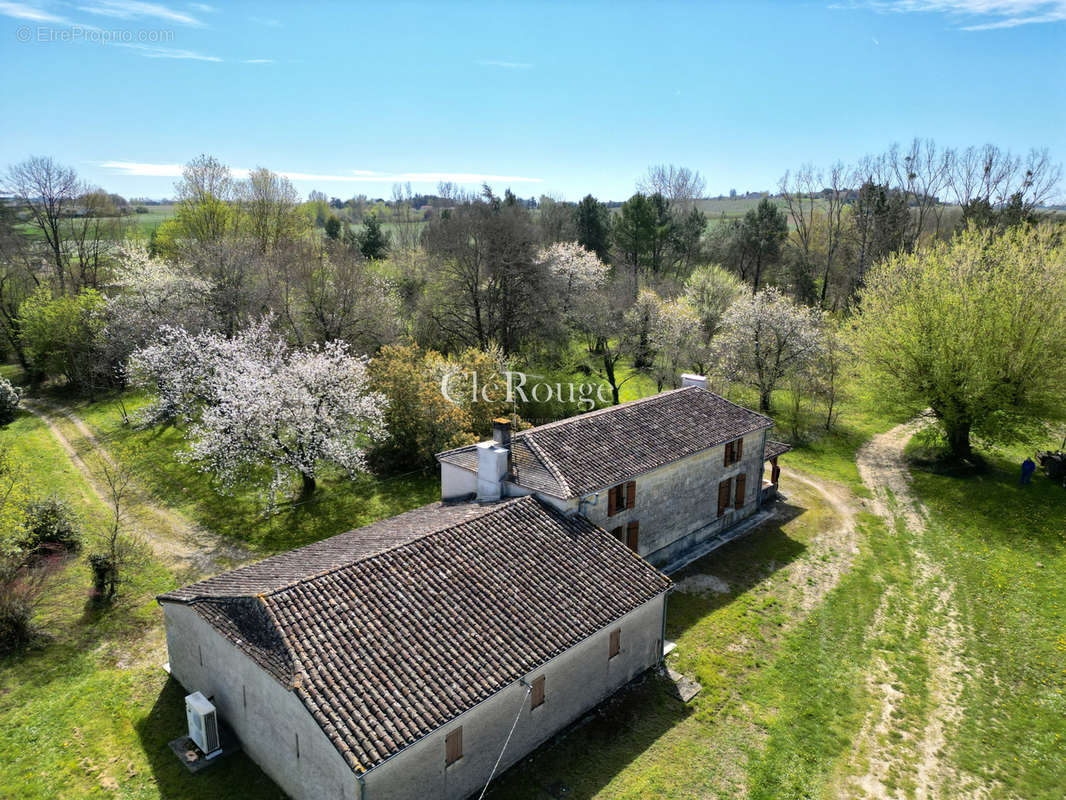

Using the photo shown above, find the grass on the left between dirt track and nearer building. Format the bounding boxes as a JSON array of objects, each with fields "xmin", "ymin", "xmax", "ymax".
[{"xmin": 0, "ymin": 412, "xmax": 279, "ymax": 800}]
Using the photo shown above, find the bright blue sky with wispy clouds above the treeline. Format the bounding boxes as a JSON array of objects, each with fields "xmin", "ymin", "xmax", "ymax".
[{"xmin": 0, "ymin": 0, "xmax": 1066, "ymax": 199}]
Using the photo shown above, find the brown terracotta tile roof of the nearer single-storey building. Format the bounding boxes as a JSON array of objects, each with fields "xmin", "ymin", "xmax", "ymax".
[{"xmin": 160, "ymin": 497, "xmax": 671, "ymax": 771}]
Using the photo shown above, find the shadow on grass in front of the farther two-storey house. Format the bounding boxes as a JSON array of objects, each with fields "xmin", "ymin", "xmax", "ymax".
[{"xmin": 666, "ymin": 500, "xmax": 807, "ymax": 639}]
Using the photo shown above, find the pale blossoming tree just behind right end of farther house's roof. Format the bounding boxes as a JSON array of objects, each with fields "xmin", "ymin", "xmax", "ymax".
[{"xmin": 714, "ymin": 288, "xmax": 821, "ymax": 412}]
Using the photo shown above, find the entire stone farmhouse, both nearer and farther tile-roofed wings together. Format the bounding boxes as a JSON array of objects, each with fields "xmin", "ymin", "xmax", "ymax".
[{"xmin": 159, "ymin": 385, "xmax": 788, "ymax": 800}]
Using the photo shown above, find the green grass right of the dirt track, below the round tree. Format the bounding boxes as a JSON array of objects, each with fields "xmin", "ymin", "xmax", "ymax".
[{"xmin": 911, "ymin": 443, "xmax": 1066, "ymax": 799}]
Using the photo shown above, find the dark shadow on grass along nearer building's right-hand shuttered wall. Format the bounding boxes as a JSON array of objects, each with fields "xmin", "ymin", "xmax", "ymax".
[{"xmin": 486, "ymin": 671, "xmax": 692, "ymax": 800}]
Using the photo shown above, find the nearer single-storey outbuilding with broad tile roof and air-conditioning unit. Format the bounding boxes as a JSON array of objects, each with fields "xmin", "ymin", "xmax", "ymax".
[{"xmin": 159, "ymin": 496, "xmax": 671, "ymax": 800}]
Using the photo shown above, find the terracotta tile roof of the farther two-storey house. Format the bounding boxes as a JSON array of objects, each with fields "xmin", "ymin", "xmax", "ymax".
[{"xmin": 437, "ymin": 386, "xmax": 773, "ymax": 498}]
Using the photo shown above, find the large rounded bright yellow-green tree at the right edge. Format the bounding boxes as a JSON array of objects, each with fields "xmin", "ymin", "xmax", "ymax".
[{"xmin": 857, "ymin": 227, "xmax": 1066, "ymax": 460}]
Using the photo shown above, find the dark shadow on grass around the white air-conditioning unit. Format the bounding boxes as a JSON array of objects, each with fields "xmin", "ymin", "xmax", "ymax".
[{"xmin": 134, "ymin": 677, "xmax": 286, "ymax": 800}]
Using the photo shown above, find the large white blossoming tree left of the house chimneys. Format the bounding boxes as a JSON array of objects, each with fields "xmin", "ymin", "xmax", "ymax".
[{"xmin": 132, "ymin": 322, "xmax": 386, "ymax": 498}]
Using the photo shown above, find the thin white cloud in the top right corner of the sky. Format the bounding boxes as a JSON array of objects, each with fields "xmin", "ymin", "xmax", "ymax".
[{"xmin": 848, "ymin": 0, "xmax": 1066, "ymax": 31}]
